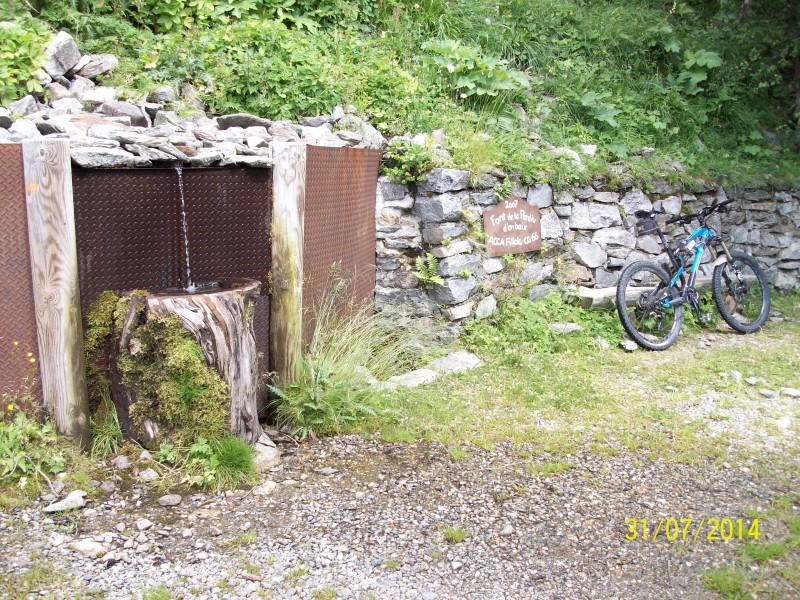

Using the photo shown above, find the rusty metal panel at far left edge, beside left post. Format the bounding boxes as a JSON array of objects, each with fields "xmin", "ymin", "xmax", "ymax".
[{"xmin": 0, "ymin": 144, "xmax": 42, "ymax": 415}]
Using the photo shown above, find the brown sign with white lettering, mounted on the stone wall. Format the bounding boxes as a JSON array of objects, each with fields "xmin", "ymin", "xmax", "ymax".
[{"xmin": 483, "ymin": 197, "xmax": 542, "ymax": 256}]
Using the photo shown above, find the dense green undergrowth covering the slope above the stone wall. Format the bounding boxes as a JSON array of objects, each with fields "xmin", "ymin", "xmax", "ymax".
[{"xmin": 6, "ymin": 0, "xmax": 800, "ymax": 186}]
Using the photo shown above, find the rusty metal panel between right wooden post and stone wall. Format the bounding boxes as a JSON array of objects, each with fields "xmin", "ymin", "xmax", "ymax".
[{"xmin": 303, "ymin": 146, "xmax": 381, "ymax": 314}]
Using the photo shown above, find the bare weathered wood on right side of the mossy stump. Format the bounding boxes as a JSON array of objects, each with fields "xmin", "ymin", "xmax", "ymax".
[{"xmin": 146, "ymin": 279, "xmax": 261, "ymax": 444}]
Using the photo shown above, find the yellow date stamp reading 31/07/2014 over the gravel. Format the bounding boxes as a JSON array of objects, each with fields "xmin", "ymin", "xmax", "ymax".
[{"xmin": 625, "ymin": 517, "xmax": 759, "ymax": 542}]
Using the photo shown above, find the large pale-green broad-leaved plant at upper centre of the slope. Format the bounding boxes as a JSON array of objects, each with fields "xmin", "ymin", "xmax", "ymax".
[{"xmin": 422, "ymin": 40, "xmax": 530, "ymax": 100}]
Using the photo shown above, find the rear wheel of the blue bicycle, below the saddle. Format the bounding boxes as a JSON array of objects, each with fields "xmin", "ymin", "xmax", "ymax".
[{"xmin": 617, "ymin": 261, "xmax": 683, "ymax": 350}]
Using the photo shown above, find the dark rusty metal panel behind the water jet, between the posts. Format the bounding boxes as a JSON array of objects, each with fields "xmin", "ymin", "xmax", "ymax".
[{"xmin": 73, "ymin": 168, "xmax": 272, "ymax": 406}]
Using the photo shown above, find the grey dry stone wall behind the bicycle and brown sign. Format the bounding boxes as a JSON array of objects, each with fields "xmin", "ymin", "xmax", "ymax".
[{"xmin": 375, "ymin": 169, "xmax": 800, "ymax": 321}]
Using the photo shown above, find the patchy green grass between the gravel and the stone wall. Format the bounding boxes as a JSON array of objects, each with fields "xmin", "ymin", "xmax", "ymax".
[{"xmin": 351, "ymin": 295, "xmax": 800, "ymax": 471}]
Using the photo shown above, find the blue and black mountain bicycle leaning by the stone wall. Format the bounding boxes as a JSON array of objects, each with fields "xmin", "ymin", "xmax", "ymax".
[{"xmin": 616, "ymin": 200, "xmax": 770, "ymax": 350}]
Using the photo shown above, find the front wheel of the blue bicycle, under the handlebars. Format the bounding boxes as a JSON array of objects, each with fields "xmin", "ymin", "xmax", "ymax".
[{"xmin": 711, "ymin": 251, "xmax": 769, "ymax": 333}]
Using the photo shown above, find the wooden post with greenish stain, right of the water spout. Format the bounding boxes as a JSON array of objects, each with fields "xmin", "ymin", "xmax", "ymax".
[{"xmin": 269, "ymin": 143, "xmax": 306, "ymax": 386}]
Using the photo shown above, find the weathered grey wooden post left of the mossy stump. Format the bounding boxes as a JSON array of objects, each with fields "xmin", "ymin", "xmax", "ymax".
[{"xmin": 22, "ymin": 140, "xmax": 90, "ymax": 448}]
